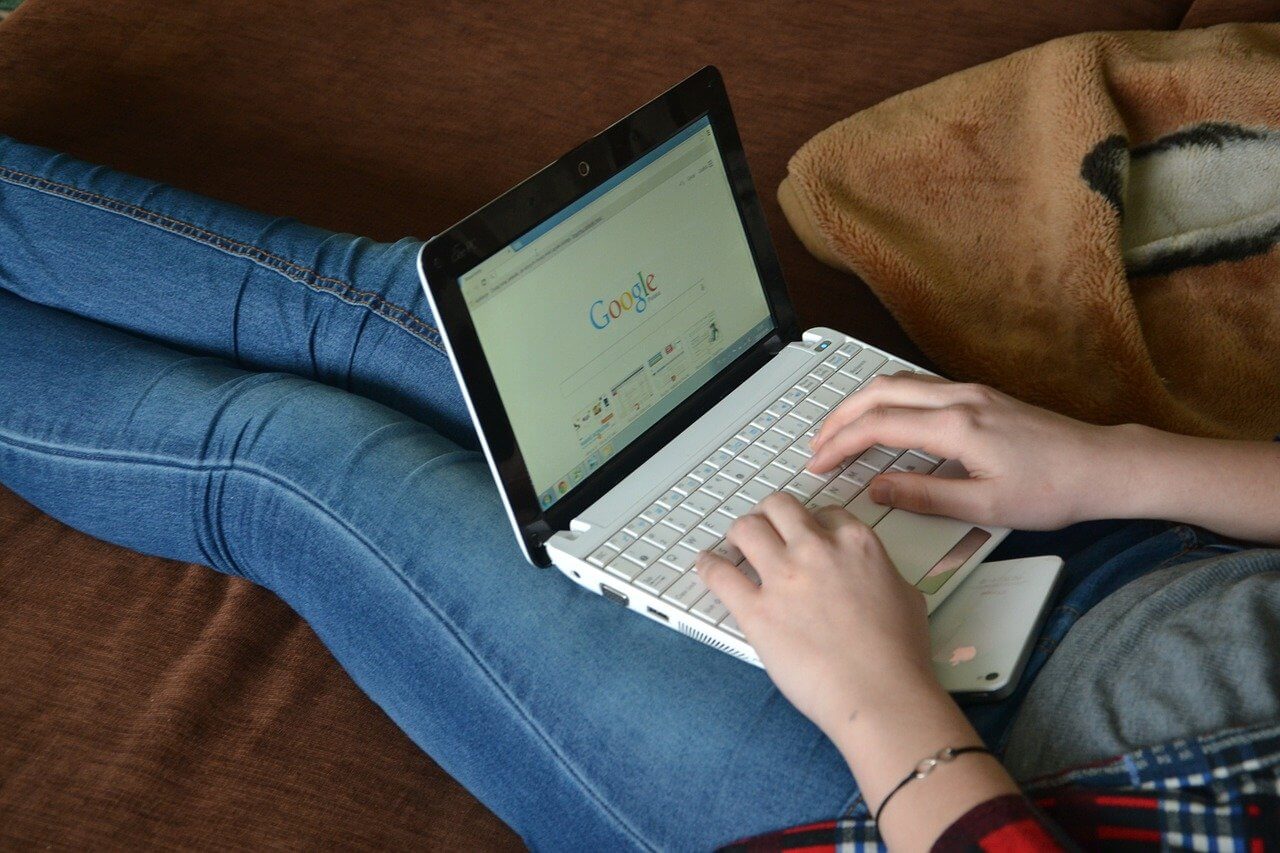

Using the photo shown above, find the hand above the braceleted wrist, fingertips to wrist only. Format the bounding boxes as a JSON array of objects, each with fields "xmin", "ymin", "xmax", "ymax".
[{"xmin": 698, "ymin": 493, "xmax": 941, "ymax": 739}]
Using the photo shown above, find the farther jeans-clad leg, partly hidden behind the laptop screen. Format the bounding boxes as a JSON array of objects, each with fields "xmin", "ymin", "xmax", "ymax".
[{"xmin": 0, "ymin": 136, "xmax": 474, "ymax": 446}]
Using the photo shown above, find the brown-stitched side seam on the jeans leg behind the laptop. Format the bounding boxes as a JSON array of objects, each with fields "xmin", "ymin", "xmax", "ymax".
[{"xmin": 0, "ymin": 167, "xmax": 444, "ymax": 352}]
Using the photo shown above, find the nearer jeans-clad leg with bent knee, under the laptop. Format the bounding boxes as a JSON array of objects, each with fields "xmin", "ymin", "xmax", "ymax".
[{"xmin": 0, "ymin": 293, "xmax": 854, "ymax": 849}]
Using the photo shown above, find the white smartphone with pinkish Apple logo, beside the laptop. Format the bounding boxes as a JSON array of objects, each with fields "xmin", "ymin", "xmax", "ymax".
[{"xmin": 929, "ymin": 557, "xmax": 1062, "ymax": 701}]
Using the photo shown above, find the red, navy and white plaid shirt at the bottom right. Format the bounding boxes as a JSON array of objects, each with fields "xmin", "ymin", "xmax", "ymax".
[{"xmin": 724, "ymin": 724, "xmax": 1280, "ymax": 853}]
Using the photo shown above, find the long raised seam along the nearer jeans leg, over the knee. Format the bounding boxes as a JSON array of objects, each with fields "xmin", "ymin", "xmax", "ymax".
[{"xmin": 0, "ymin": 432, "xmax": 658, "ymax": 850}]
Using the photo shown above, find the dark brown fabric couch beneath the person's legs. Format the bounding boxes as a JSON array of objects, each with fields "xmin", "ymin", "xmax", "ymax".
[{"xmin": 0, "ymin": 0, "xmax": 1276, "ymax": 848}]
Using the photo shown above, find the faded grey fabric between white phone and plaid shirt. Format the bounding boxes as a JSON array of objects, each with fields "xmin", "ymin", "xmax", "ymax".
[{"xmin": 1005, "ymin": 549, "xmax": 1280, "ymax": 780}]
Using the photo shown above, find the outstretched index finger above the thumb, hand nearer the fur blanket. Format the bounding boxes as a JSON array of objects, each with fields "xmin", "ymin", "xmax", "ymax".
[{"xmin": 806, "ymin": 407, "xmax": 964, "ymax": 474}]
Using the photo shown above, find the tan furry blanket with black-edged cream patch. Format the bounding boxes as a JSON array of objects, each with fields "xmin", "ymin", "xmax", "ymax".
[{"xmin": 778, "ymin": 24, "xmax": 1280, "ymax": 438}]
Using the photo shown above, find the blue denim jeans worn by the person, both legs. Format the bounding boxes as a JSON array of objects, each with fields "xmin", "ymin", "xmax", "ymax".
[{"xmin": 0, "ymin": 137, "xmax": 1239, "ymax": 849}]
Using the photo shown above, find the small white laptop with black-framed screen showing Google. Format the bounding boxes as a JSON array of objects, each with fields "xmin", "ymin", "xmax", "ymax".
[{"xmin": 419, "ymin": 67, "xmax": 1007, "ymax": 666}]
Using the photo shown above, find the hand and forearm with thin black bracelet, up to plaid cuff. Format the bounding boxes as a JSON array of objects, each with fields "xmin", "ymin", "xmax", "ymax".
[{"xmin": 698, "ymin": 493, "xmax": 1018, "ymax": 849}]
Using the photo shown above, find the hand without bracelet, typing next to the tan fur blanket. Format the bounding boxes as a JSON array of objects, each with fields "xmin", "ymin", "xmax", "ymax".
[{"xmin": 809, "ymin": 374, "xmax": 1125, "ymax": 530}]
